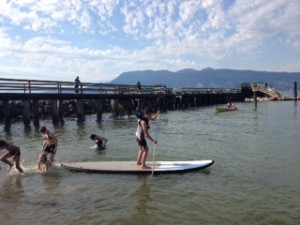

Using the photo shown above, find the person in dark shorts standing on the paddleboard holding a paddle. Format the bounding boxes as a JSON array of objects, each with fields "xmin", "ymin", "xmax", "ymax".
[{"xmin": 135, "ymin": 109, "xmax": 160, "ymax": 169}]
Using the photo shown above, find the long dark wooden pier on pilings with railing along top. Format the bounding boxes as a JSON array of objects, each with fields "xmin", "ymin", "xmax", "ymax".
[{"xmin": 0, "ymin": 78, "xmax": 248, "ymax": 127}]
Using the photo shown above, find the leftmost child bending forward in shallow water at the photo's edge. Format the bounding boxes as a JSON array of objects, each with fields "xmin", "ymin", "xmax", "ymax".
[{"xmin": 0, "ymin": 140, "xmax": 23, "ymax": 173}]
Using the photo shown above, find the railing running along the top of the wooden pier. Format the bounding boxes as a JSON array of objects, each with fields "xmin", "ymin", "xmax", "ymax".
[{"xmin": 0, "ymin": 78, "xmax": 240, "ymax": 95}]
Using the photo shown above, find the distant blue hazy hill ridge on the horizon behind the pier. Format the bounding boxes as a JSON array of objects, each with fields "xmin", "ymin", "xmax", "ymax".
[{"xmin": 110, "ymin": 68, "xmax": 300, "ymax": 90}]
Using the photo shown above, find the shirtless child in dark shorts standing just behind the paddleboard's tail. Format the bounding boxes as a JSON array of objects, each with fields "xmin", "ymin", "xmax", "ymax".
[{"xmin": 40, "ymin": 126, "xmax": 58, "ymax": 163}]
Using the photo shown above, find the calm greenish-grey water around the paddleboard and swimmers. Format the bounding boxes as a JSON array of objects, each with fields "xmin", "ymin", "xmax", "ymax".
[{"xmin": 0, "ymin": 102, "xmax": 300, "ymax": 225}]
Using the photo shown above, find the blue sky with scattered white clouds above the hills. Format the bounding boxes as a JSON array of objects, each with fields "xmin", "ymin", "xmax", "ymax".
[{"xmin": 0, "ymin": 0, "xmax": 300, "ymax": 83}]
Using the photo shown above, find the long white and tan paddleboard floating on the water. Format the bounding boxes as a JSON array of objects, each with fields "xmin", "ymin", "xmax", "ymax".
[{"xmin": 61, "ymin": 160, "xmax": 214, "ymax": 174}]
